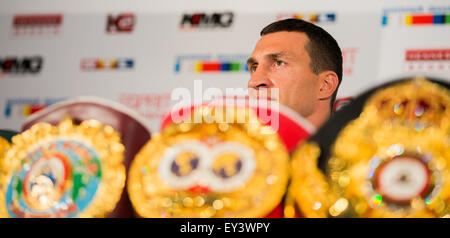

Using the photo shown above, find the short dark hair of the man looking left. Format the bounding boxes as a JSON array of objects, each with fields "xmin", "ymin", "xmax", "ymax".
[{"xmin": 260, "ymin": 19, "xmax": 342, "ymax": 109}]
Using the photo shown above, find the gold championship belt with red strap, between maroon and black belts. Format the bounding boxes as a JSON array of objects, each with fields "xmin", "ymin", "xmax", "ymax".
[{"xmin": 128, "ymin": 96, "xmax": 313, "ymax": 218}]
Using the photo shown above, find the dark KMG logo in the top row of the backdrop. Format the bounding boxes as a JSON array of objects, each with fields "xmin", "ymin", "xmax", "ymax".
[{"xmin": 180, "ymin": 12, "xmax": 234, "ymax": 30}]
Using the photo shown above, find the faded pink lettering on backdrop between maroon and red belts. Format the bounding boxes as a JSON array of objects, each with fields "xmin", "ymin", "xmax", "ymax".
[{"xmin": 119, "ymin": 93, "xmax": 171, "ymax": 120}]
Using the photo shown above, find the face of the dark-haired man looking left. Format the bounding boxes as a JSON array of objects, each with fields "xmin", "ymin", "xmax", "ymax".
[{"xmin": 247, "ymin": 31, "xmax": 320, "ymax": 117}]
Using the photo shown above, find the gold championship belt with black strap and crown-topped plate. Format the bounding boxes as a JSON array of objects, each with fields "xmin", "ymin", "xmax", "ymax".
[{"xmin": 285, "ymin": 78, "xmax": 450, "ymax": 217}]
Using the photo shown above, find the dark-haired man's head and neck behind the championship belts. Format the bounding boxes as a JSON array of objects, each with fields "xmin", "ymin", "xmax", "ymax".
[{"xmin": 247, "ymin": 19, "xmax": 342, "ymax": 128}]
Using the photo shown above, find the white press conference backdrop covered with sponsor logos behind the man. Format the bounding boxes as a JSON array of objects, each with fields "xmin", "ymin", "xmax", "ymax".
[{"xmin": 0, "ymin": 0, "xmax": 450, "ymax": 131}]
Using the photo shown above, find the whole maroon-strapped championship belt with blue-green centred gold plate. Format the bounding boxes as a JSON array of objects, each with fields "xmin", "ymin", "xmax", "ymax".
[{"xmin": 0, "ymin": 97, "xmax": 150, "ymax": 217}]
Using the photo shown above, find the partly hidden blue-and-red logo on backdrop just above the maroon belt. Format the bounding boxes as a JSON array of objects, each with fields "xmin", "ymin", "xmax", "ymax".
[{"xmin": 4, "ymin": 97, "xmax": 65, "ymax": 118}]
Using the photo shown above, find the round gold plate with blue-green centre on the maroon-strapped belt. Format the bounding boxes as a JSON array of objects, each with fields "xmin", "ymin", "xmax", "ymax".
[{"xmin": 0, "ymin": 119, "xmax": 125, "ymax": 218}]
